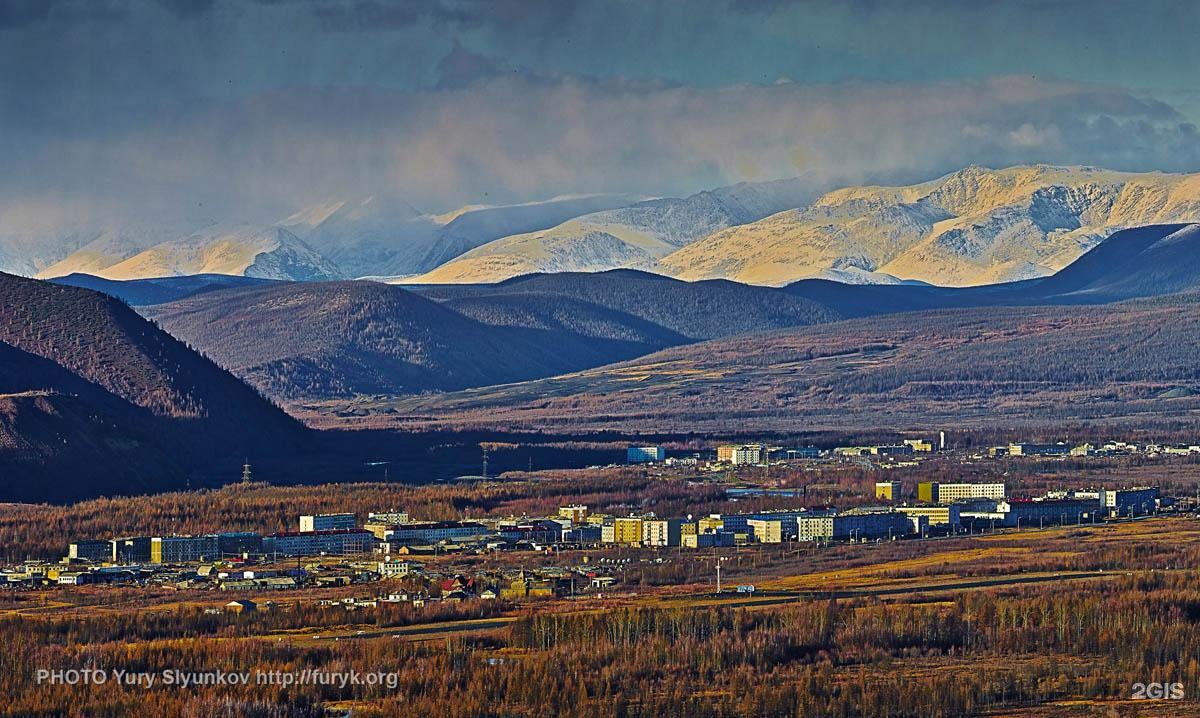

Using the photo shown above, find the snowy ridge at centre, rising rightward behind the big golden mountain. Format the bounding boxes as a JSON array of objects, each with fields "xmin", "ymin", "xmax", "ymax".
[{"xmin": 410, "ymin": 179, "xmax": 816, "ymax": 283}]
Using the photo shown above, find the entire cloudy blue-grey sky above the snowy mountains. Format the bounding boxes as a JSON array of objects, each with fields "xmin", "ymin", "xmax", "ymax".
[{"xmin": 0, "ymin": 0, "xmax": 1200, "ymax": 229}]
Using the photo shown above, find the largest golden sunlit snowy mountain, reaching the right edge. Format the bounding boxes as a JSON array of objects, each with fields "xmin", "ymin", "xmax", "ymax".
[{"xmin": 658, "ymin": 166, "xmax": 1200, "ymax": 286}]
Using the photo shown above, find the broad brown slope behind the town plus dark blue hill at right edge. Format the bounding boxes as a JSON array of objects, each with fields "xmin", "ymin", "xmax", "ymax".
[{"xmin": 325, "ymin": 225, "xmax": 1200, "ymax": 435}]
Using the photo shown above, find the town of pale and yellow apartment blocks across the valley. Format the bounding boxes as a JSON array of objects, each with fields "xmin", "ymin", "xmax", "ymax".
[{"xmin": 0, "ymin": 435, "xmax": 1180, "ymax": 606}]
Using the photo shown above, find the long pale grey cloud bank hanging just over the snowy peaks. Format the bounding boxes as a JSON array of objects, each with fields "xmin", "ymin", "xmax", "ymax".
[{"xmin": 0, "ymin": 72, "xmax": 1200, "ymax": 234}]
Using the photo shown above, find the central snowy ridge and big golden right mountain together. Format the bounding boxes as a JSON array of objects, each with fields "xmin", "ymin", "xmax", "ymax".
[{"xmin": 409, "ymin": 166, "xmax": 1200, "ymax": 286}]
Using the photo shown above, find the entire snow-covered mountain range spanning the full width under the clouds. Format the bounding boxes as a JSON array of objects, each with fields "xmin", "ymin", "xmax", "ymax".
[{"xmin": 18, "ymin": 164, "xmax": 1200, "ymax": 286}]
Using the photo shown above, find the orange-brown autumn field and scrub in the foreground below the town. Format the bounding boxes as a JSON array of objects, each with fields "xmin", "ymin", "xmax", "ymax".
[{"xmin": 0, "ymin": 519, "xmax": 1200, "ymax": 716}]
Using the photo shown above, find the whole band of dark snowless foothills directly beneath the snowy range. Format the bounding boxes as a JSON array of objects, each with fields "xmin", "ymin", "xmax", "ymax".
[{"xmin": 72, "ymin": 225, "xmax": 1200, "ymax": 402}]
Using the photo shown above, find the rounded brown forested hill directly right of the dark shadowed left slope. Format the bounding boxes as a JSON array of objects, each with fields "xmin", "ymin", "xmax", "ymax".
[{"xmin": 146, "ymin": 282, "xmax": 696, "ymax": 399}]
